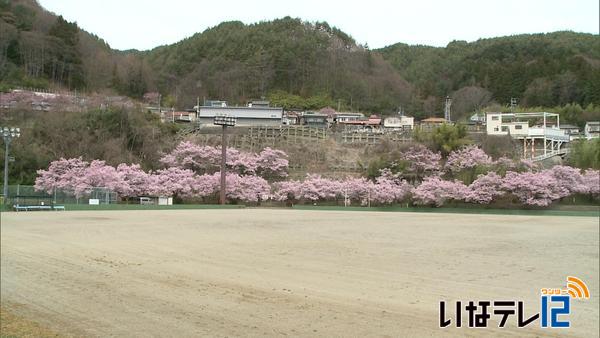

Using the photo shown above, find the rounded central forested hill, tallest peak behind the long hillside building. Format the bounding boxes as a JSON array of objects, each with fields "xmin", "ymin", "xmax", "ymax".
[{"xmin": 144, "ymin": 17, "xmax": 411, "ymax": 111}]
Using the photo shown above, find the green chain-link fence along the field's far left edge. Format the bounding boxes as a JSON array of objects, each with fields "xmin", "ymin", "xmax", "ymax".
[{"xmin": 0, "ymin": 185, "xmax": 118, "ymax": 205}]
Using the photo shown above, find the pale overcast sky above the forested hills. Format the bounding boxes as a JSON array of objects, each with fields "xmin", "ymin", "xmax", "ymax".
[{"xmin": 38, "ymin": 0, "xmax": 600, "ymax": 50}]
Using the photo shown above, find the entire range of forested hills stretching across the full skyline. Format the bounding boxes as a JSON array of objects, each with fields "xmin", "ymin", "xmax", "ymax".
[{"xmin": 0, "ymin": 0, "xmax": 600, "ymax": 119}]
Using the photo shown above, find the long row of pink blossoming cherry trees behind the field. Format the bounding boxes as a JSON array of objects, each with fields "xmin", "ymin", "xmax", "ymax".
[{"xmin": 36, "ymin": 142, "xmax": 600, "ymax": 206}]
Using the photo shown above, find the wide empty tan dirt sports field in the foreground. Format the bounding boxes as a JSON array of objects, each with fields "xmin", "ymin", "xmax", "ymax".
[{"xmin": 1, "ymin": 209, "xmax": 600, "ymax": 337}]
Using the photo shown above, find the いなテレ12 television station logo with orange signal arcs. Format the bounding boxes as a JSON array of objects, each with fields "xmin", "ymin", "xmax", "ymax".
[{"xmin": 439, "ymin": 276, "xmax": 590, "ymax": 328}]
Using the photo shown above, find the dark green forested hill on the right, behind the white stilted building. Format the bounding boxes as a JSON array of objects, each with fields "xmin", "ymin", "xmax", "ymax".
[{"xmin": 379, "ymin": 32, "xmax": 600, "ymax": 119}]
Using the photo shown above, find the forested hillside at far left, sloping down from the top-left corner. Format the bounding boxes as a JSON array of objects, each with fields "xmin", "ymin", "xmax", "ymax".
[{"xmin": 0, "ymin": 0, "xmax": 154, "ymax": 97}]
